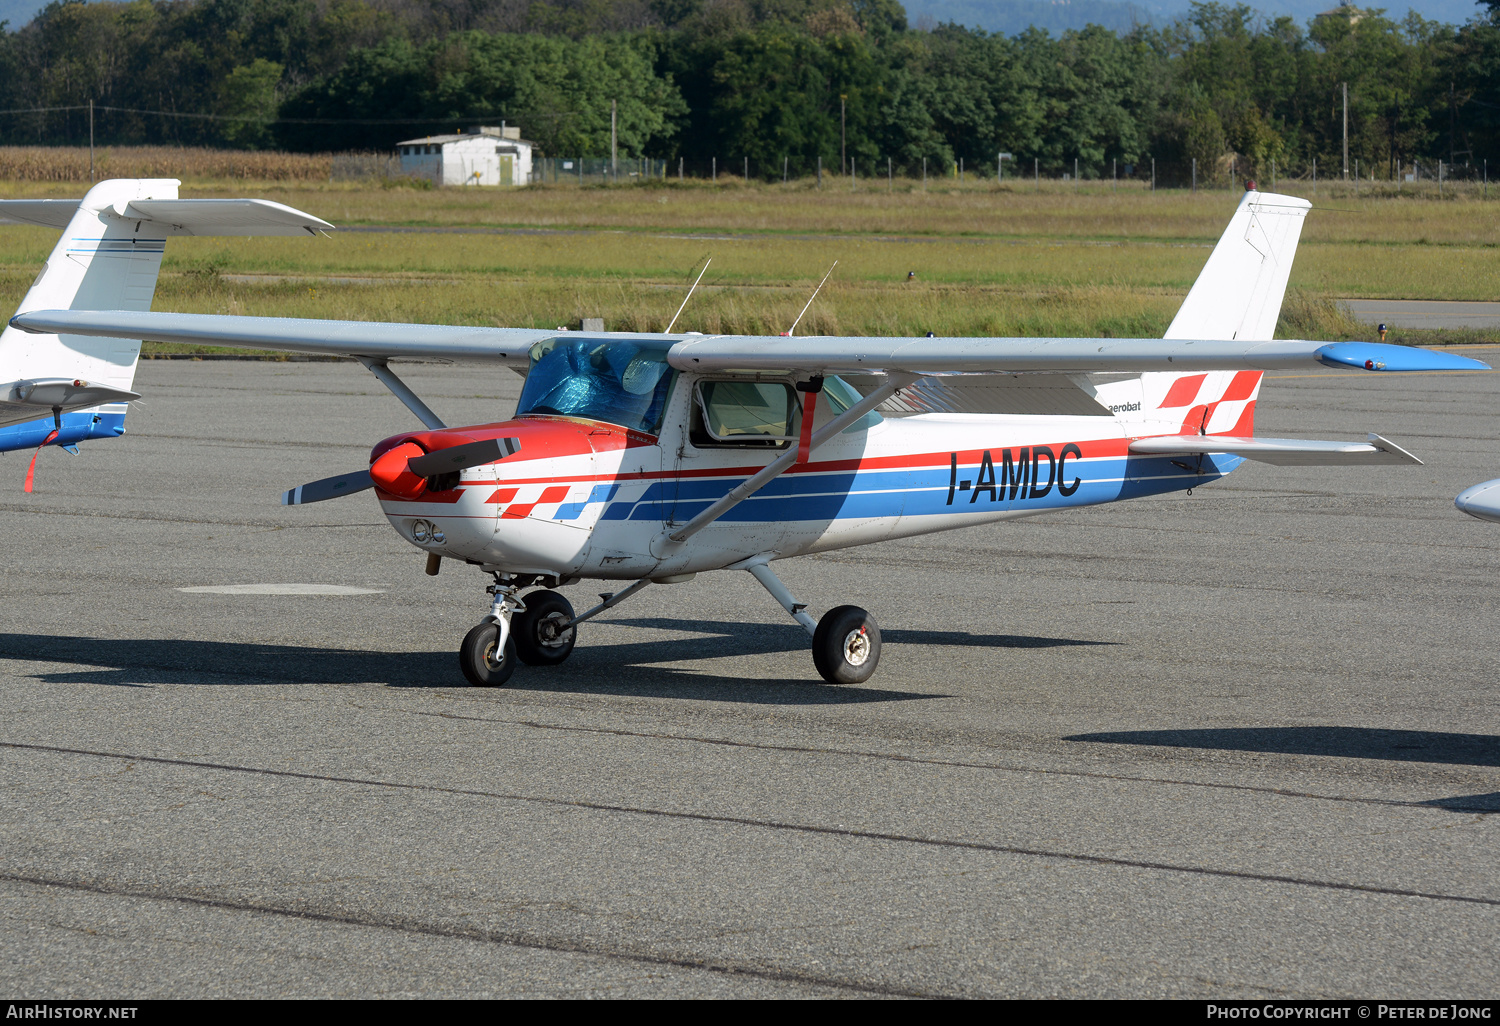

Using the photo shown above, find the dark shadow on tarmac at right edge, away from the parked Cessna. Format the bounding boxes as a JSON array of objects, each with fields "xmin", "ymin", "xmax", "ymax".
[{"xmin": 1064, "ymin": 726, "xmax": 1500, "ymax": 765}]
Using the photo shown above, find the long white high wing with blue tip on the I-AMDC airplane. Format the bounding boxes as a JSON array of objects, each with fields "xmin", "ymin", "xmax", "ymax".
[{"xmin": 11, "ymin": 311, "xmax": 1490, "ymax": 375}]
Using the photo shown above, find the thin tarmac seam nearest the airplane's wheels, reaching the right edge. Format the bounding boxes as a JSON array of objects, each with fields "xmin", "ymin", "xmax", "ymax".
[{"xmin": 399, "ymin": 708, "xmax": 1497, "ymax": 816}]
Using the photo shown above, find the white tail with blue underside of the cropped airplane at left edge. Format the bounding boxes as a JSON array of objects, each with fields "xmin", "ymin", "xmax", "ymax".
[{"xmin": 0, "ymin": 179, "xmax": 333, "ymax": 492}]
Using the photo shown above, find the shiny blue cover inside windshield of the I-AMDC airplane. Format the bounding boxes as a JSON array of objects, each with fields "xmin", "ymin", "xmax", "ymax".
[{"xmin": 516, "ymin": 338, "xmax": 677, "ymax": 435}]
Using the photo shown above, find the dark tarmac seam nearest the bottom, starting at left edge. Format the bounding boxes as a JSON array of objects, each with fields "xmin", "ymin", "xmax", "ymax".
[{"xmin": 0, "ymin": 873, "xmax": 950, "ymax": 998}]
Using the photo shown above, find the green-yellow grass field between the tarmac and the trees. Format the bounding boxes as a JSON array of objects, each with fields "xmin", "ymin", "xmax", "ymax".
[{"xmin": 0, "ymin": 171, "xmax": 1500, "ymax": 352}]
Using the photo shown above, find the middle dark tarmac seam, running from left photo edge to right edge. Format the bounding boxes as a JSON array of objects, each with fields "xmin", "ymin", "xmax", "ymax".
[{"xmin": 0, "ymin": 741, "xmax": 1500, "ymax": 908}]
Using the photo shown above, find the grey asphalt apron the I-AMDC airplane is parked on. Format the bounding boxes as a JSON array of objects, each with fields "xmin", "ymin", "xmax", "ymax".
[{"xmin": 0, "ymin": 353, "xmax": 1500, "ymax": 999}]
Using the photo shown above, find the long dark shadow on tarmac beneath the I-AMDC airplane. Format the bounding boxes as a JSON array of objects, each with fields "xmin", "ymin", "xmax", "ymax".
[{"xmin": 0, "ymin": 618, "xmax": 1113, "ymax": 705}]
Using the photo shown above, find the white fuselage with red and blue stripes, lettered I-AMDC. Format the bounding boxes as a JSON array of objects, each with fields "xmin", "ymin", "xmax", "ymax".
[{"xmin": 372, "ymin": 345, "xmax": 1259, "ymax": 581}]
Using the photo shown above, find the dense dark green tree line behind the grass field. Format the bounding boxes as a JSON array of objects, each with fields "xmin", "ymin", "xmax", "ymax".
[{"xmin": 0, "ymin": 0, "xmax": 1500, "ymax": 183}]
